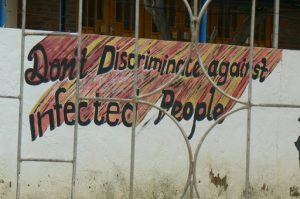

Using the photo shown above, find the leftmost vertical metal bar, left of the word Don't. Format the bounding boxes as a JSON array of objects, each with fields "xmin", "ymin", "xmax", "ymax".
[{"xmin": 16, "ymin": 0, "xmax": 26, "ymax": 199}]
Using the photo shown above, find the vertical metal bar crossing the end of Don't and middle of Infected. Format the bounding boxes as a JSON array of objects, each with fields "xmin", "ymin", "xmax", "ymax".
[{"xmin": 71, "ymin": 0, "xmax": 82, "ymax": 199}]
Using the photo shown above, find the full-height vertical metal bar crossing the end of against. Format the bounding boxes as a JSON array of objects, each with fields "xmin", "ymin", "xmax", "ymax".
[{"xmin": 245, "ymin": 0, "xmax": 256, "ymax": 199}]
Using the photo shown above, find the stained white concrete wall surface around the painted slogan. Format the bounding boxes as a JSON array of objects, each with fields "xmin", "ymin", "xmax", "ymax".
[{"xmin": 0, "ymin": 29, "xmax": 300, "ymax": 199}]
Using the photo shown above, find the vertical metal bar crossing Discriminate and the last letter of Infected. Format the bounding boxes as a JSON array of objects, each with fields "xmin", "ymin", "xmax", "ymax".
[{"xmin": 129, "ymin": 0, "xmax": 140, "ymax": 199}]
